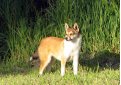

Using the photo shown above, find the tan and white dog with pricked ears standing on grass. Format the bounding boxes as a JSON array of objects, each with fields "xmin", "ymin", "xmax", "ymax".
[{"xmin": 30, "ymin": 23, "xmax": 82, "ymax": 76}]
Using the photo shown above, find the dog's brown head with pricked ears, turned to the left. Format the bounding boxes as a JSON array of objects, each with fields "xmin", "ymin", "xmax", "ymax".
[{"xmin": 65, "ymin": 23, "xmax": 79, "ymax": 41}]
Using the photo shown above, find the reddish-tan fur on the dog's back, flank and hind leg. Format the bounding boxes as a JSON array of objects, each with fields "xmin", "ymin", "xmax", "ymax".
[{"xmin": 38, "ymin": 37, "xmax": 64, "ymax": 74}]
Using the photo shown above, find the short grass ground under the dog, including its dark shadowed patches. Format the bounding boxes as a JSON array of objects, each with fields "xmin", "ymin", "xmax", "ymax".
[{"xmin": 0, "ymin": 51, "xmax": 120, "ymax": 85}]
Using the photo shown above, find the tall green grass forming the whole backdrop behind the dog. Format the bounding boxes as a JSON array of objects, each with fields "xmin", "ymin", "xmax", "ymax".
[{"xmin": 0, "ymin": 0, "xmax": 120, "ymax": 65}]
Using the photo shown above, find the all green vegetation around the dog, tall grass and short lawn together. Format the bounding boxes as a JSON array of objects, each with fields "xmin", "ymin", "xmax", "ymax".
[{"xmin": 0, "ymin": 0, "xmax": 120, "ymax": 85}]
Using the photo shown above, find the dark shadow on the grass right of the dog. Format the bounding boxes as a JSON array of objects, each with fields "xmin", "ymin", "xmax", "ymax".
[{"xmin": 80, "ymin": 50, "xmax": 120, "ymax": 71}]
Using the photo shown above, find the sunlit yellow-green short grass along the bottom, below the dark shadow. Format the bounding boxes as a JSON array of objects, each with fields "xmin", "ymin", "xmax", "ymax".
[{"xmin": 0, "ymin": 61, "xmax": 120, "ymax": 85}]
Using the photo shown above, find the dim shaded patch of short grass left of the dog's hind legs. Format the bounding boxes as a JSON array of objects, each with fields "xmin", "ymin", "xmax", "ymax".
[{"xmin": 0, "ymin": 62, "xmax": 31, "ymax": 76}]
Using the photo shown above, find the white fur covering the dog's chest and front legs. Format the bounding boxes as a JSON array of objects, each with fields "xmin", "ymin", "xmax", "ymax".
[{"xmin": 61, "ymin": 35, "xmax": 82, "ymax": 76}]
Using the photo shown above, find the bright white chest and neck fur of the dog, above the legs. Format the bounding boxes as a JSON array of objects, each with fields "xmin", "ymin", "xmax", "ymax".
[{"xmin": 64, "ymin": 35, "xmax": 82, "ymax": 60}]
